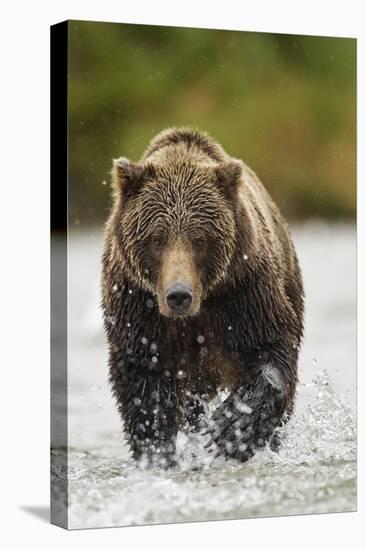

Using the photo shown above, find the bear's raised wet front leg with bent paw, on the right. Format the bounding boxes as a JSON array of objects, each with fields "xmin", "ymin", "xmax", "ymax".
[{"xmin": 205, "ymin": 348, "xmax": 296, "ymax": 462}]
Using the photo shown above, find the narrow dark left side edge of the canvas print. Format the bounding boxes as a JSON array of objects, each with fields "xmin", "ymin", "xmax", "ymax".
[{"xmin": 51, "ymin": 22, "xmax": 68, "ymax": 528}]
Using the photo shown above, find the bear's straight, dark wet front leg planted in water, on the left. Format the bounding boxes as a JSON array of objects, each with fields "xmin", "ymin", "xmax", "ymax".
[{"xmin": 110, "ymin": 354, "xmax": 182, "ymax": 468}]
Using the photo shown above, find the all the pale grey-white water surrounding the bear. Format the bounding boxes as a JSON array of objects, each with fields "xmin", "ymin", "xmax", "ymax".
[{"xmin": 56, "ymin": 223, "xmax": 356, "ymax": 529}]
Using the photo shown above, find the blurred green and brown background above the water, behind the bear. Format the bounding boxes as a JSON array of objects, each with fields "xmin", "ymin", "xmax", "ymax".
[{"xmin": 68, "ymin": 21, "xmax": 356, "ymax": 225}]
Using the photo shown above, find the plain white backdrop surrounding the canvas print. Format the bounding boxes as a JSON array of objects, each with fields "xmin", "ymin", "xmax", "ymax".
[{"xmin": 0, "ymin": 0, "xmax": 366, "ymax": 550}]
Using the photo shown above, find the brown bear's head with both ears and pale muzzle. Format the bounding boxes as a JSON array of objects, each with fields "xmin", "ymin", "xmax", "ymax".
[{"xmin": 113, "ymin": 156, "xmax": 242, "ymax": 317}]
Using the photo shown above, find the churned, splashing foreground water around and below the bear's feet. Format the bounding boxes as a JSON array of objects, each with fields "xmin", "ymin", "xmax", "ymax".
[{"xmin": 56, "ymin": 370, "xmax": 356, "ymax": 528}]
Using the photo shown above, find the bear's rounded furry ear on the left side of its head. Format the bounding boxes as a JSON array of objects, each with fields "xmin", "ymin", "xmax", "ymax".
[{"xmin": 112, "ymin": 157, "xmax": 154, "ymax": 200}]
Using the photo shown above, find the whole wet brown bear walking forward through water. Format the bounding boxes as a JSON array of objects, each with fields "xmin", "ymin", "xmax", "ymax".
[{"xmin": 102, "ymin": 128, "xmax": 304, "ymax": 466}]
